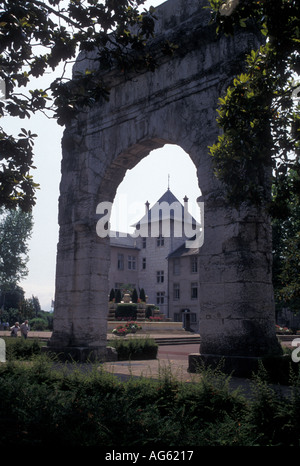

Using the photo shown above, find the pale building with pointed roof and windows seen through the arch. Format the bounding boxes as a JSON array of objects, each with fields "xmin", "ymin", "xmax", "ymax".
[{"xmin": 109, "ymin": 189, "xmax": 199, "ymax": 331}]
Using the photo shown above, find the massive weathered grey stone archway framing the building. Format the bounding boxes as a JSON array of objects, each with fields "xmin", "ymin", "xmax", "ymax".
[{"xmin": 45, "ymin": 0, "xmax": 280, "ymax": 372}]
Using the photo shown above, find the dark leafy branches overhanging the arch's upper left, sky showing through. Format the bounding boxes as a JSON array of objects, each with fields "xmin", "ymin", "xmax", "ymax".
[{"xmin": 0, "ymin": 0, "xmax": 159, "ymax": 211}]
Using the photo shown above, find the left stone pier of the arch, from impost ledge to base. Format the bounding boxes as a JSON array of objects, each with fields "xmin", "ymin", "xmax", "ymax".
[{"xmin": 49, "ymin": 226, "xmax": 109, "ymax": 361}]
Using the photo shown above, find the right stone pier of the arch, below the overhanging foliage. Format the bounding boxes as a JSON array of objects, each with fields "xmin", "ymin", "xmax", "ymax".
[{"xmin": 189, "ymin": 192, "xmax": 282, "ymax": 376}]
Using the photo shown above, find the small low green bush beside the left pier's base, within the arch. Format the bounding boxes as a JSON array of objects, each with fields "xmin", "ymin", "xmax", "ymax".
[{"xmin": 109, "ymin": 337, "xmax": 158, "ymax": 361}]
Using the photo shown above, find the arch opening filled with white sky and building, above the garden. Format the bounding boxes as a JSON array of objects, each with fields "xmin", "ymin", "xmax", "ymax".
[{"xmin": 108, "ymin": 144, "xmax": 201, "ymax": 332}]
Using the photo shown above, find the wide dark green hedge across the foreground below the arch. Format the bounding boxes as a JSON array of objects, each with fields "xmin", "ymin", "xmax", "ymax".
[{"xmin": 0, "ymin": 356, "xmax": 300, "ymax": 450}]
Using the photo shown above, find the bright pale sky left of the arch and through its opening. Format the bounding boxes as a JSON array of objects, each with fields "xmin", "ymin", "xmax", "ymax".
[{"xmin": 1, "ymin": 0, "xmax": 200, "ymax": 311}]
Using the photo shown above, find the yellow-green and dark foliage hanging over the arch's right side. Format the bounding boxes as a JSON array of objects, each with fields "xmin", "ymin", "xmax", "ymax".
[{"xmin": 209, "ymin": 0, "xmax": 300, "ymax": 217}]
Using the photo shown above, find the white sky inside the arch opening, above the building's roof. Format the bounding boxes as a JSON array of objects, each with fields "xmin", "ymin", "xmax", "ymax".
[{"xmin": 110, "ymin": 144, "xmax": 201, "ymax": 233}]
